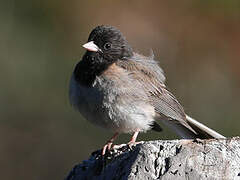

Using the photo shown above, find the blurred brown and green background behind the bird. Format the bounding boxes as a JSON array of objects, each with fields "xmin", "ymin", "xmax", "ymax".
[{"xmin": 0, "ymin": 0, "xmax": 240, "ymax": 180}]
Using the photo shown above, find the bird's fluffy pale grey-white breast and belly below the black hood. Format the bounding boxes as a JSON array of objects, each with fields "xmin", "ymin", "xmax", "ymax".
[{"xmin": 69, "ymin": 72, "xmax": 155, "ymax": 133}]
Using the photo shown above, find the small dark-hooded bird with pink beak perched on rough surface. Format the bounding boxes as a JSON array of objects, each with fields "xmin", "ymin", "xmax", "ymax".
[{"xmin": 69, "ymin": 25, "xmax": 225, "ymax": 155}]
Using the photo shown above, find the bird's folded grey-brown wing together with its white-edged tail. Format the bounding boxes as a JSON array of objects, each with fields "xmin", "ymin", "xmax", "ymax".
[{"xmin": 117, "ymin": 53, "xmax": 224, "ymax": 139}]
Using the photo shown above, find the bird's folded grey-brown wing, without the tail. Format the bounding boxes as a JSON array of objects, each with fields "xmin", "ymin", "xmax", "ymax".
[{"xmin": 116, "ymin": 53, "xmax": 195, "ymax": 132}]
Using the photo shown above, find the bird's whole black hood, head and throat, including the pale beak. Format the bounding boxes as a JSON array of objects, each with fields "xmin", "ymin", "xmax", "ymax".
[{"xmin": 74, "ymin": 25, "xmax": 133, "ymax": 85}]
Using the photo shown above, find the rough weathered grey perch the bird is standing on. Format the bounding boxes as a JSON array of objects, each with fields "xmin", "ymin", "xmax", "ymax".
[{"xmin": 66, "ymin": 137, "xmax": 240, "ymax": 180}]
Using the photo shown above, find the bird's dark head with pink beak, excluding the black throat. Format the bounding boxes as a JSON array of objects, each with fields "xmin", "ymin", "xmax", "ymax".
[{"xmin": 83, "ymin": 25, "xmax": 133, "ymax": 64}]
